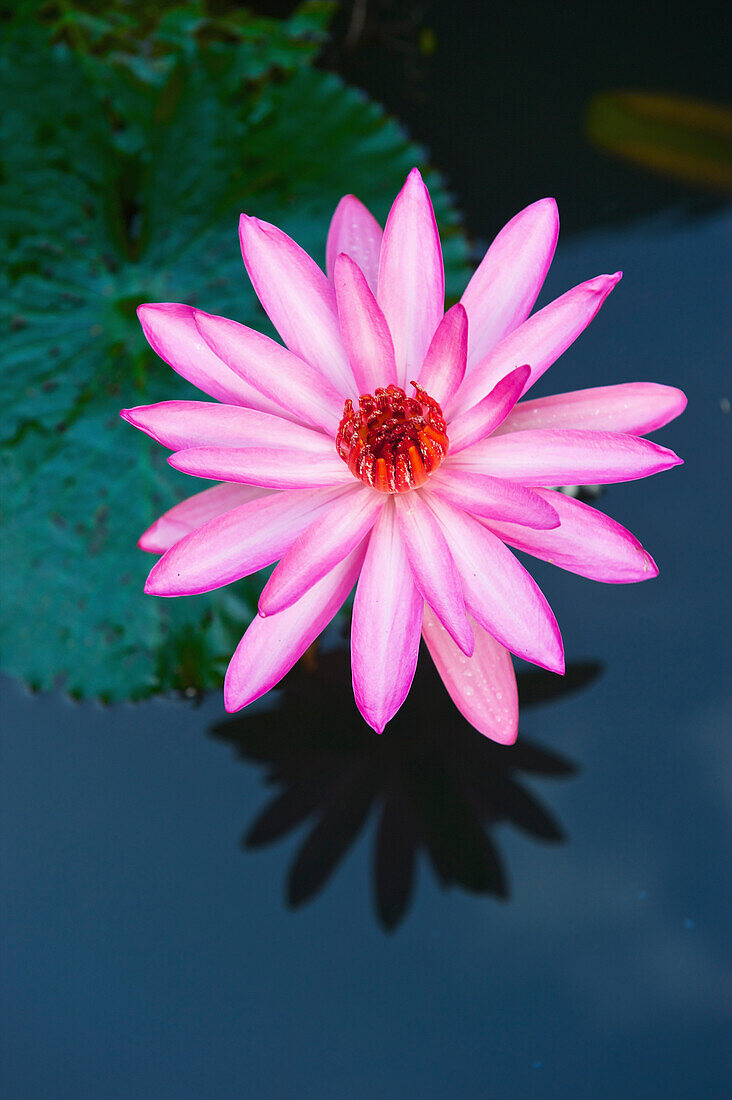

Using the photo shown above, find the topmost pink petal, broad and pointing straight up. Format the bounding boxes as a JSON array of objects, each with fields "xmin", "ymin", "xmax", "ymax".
[{"xmin": 376, "ymin": 168, "xmax": 445, "ymax": 388}]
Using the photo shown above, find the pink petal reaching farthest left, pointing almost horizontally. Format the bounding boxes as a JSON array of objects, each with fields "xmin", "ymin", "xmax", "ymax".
[{"xmin": 120, "ymin": 402, "xmax": 332, "ymax": 453}]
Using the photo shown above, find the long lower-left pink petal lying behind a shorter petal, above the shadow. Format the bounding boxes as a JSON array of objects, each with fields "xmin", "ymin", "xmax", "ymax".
[{"xmin": 223, "ymin": 547, "xmax": 364, "ymax": 713}]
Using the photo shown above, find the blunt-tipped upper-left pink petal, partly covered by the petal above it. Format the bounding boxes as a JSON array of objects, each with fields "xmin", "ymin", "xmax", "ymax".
[{"xmin": 138, "ymin": 301, "xmax": 282, "ymax": 414}]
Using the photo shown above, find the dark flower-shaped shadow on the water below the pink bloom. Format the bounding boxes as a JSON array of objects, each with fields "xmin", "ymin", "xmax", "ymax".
[{"xmin": 211, "ymin": 649, "xmax": 601, "ymax": 930}]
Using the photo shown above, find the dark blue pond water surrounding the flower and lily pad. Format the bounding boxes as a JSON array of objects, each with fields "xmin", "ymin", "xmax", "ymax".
[{"xmin": 1, "ymin": 3, "xmax": 732, "ymax": 1100}]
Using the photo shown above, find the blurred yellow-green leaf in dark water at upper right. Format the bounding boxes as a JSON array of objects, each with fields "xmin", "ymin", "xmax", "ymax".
[{"xmin": 584, "ymin": 91, "xmax": 732, "ymax": 191}]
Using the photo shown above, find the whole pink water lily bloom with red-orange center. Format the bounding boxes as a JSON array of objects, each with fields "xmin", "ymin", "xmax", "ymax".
[{"xmin": 122, "ymin": 168, "xmax": 686, "ymax": 744}]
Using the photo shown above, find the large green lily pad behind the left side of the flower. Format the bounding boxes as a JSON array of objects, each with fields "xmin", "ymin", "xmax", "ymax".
[{"xmin": 0, "ymin": 3, "xmax": 466, "ymax": 700}]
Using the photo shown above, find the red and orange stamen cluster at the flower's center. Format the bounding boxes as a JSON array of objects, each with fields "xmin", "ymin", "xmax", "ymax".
[{"xmin": 336, "ymin": 382, "xmax": 448, "ymax": 493}]
